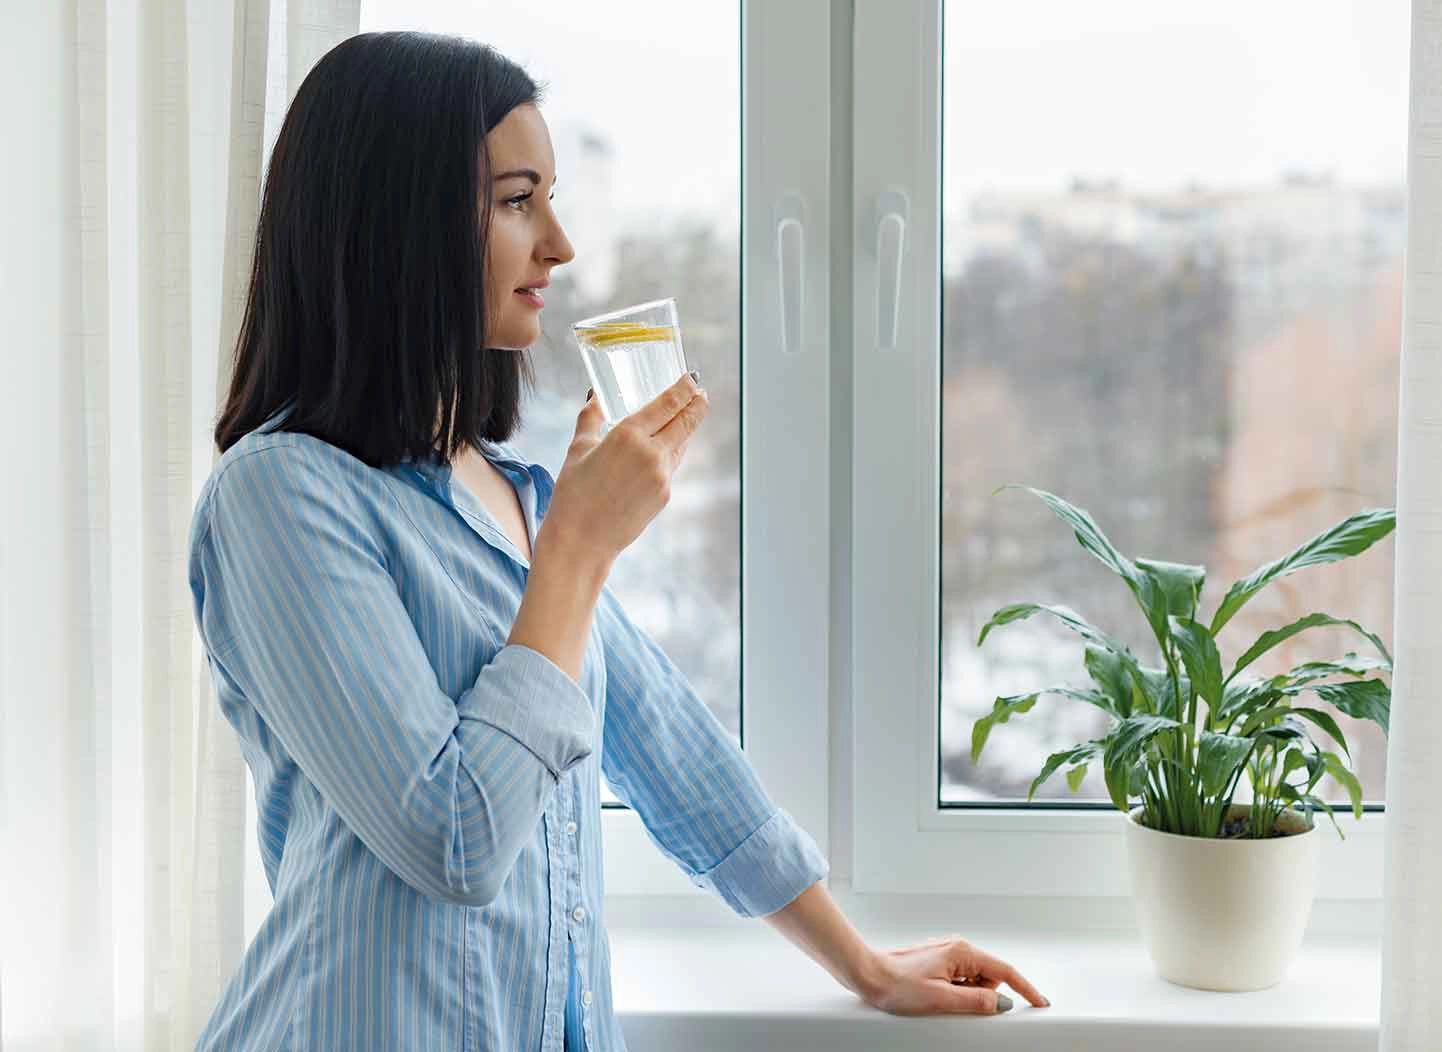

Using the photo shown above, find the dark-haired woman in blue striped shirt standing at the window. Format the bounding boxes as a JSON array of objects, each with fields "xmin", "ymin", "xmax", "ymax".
[{"xmin": 189, "ymin": 33, "xmax": 1040, "ymax": 1051}]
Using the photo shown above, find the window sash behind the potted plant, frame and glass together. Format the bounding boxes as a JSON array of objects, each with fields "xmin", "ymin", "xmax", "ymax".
[{"xmin": 852, "ymin": 0, "xmax": 1407, "ymax": 898}]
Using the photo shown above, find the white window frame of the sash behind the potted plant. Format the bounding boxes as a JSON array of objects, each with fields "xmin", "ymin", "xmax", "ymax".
[{"xmin": 844, "ymin": 0, "xmax": 1386, "ymax": 901}]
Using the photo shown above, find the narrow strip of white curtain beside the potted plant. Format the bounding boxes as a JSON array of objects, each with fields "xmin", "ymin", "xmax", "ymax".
[{"xmin": 1380, "ymin": 0, "xmax": 1442, "ymax": 1052}]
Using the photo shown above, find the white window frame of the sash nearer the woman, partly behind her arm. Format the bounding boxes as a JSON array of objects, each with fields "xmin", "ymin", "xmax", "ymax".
[{"xmin": 601, "ymin": 0, "xmax": 832, "ymax": 896}]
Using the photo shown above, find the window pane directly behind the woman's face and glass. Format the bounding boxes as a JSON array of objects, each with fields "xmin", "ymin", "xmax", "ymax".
[{"xmin": 361, "ymin": 0, "xmax": 741, "ymax": 801}]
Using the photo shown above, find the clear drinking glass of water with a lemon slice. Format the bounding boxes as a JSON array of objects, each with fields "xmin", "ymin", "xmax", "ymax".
[{"xmin": 571, "ymin": 298, "xmax": 686, "ymax": 425}]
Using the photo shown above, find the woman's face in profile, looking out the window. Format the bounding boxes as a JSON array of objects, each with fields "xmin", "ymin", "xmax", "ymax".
[{"xmin": 486, "ymin": 104, "xmax": 575, "ymax": 350}]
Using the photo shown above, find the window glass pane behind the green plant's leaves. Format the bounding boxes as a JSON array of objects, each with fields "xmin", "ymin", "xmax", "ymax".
[{"xmin": 940, "ymin": 0, "xmax": 1409, "ymax": 804}]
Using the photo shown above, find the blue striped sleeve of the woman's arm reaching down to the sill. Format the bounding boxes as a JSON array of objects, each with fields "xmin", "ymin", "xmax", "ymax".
[{"xmin": 596, "ymin": 588, "xmax": 829, "ymax": 917}]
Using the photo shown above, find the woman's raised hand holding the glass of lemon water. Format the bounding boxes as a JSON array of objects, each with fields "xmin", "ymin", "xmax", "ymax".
[{"xmin": 536, "ymin": 373, "xmax": 709, "ymax": 566}]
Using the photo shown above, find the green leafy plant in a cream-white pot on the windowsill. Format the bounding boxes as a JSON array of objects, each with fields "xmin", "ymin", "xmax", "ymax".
[{"xmin": 972, "ymin": 486, "xmax": 1396, "ymax": 990}]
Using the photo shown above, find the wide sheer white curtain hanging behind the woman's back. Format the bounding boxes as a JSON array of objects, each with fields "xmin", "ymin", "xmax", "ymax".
[{"xmin": 0, "ymin": 0, "xmax": 359, "ymax": 1052}]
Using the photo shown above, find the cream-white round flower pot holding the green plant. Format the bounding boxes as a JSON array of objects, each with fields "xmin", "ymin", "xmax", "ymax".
[{"xmin": 1126, "ymin": 804, "xmax": 1318, "ymax": 990}]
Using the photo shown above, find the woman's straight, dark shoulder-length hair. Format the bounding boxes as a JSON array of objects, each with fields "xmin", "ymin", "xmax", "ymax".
[{"xmin": 215, "ymin": 32, "xmax": 541, "ymax": 467}]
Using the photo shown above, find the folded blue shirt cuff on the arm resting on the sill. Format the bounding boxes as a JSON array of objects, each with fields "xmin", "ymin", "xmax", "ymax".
[{"xmin": 691, "ymin": 808, "xmax": 831, "ymax": 917}]
